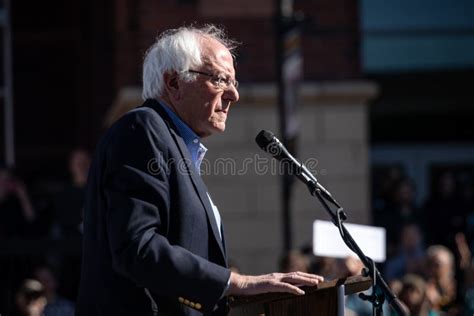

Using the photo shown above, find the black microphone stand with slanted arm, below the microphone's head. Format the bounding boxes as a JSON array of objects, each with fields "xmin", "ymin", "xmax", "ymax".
[{"xmin": 298, "ymin": 178, "xmax": 409, "ymax": 316}]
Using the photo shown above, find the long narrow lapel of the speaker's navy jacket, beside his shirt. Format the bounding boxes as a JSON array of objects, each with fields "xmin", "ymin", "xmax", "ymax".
[{"xmin": 144, "ymin": 100, "xmax": 226, "ymax": 262}]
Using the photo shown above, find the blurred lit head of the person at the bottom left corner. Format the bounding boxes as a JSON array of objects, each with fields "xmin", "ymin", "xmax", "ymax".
[{"xmin": 14, "ymin": 279, "xmax": 46, "ymax": 316}]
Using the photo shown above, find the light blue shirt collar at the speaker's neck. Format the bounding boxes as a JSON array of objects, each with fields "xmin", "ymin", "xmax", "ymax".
[{"xmin": 158, "ymin": 100, "xmax": 207, "ymax": 170}]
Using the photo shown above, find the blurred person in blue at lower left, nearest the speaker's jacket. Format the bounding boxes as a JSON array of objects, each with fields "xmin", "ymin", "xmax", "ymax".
[{"xmin": 34, "ymin": 265, "xmax": 74, "ymax": 316}]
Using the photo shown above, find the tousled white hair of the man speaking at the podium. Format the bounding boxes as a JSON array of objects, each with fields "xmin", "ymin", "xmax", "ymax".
[{"xmin": 142, "ymin": 24, "xmax": 238, "ymax": 100}]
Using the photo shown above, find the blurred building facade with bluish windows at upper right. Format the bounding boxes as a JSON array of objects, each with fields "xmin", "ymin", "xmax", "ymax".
[{"xmin": 360, "ymin": 0, "xmax": 474, "ymax": 205}]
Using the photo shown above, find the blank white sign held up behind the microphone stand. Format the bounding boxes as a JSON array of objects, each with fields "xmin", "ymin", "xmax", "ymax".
[{"xmin": 313, "ymin": 220, "xmax": 386, "ymax": 262}]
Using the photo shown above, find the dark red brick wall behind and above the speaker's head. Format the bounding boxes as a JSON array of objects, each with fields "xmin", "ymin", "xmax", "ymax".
[{"xmin": 115, "ymin": 0, "xmax": 360, "ymax": 88}]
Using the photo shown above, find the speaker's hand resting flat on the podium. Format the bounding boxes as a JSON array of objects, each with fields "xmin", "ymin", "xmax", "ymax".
[{"xmin": 226, "ymin": 272, "xmax": 324, "ymax": 295}]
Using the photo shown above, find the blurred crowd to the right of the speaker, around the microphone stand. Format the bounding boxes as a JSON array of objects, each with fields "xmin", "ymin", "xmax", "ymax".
[{"xmin": 274, "ymin": 168, "xmax": 474, "ymax": 316}]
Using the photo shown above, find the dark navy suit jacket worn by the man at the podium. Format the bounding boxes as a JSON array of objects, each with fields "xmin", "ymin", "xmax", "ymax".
[{"xmin": 76, "ymin": 100, "xmax": 230, "ymax": 316}]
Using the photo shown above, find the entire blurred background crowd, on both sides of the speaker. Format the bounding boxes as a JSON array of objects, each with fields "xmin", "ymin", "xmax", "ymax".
[{"xmin": 0, "ymin": 154, "xmax": 474, "ymax": 316}]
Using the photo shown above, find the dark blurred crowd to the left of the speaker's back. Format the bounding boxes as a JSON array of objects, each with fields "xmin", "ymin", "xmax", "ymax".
[{"xmin": 0, "ymin": 148, "xmax": 90, "ymax": 316}]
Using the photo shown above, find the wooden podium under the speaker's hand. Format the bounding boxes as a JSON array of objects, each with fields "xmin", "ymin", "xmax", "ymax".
[{"xmin": 229, "ymin": 276, "xmax": 372, "ymax": 316}]
